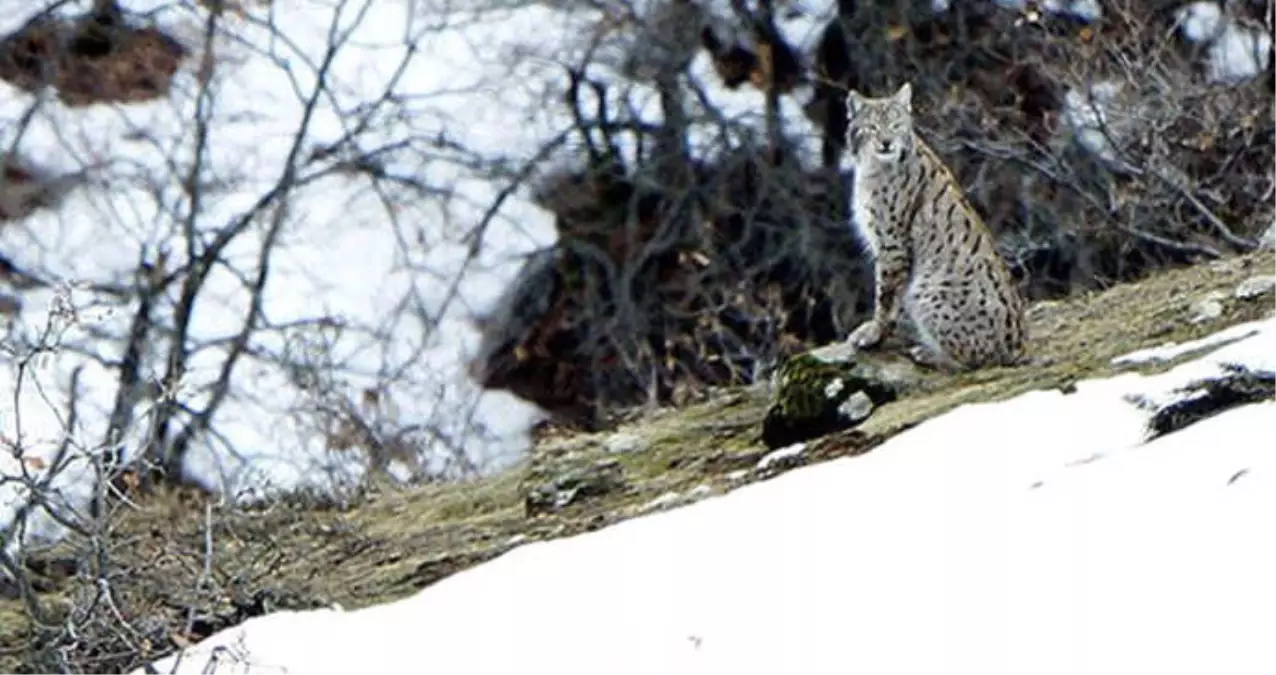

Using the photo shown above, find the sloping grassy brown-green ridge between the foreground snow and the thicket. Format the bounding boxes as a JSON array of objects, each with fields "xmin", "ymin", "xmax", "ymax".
[{"xmin": 0, "ymin": 251, "xmax": 1276, "ymax": 672}]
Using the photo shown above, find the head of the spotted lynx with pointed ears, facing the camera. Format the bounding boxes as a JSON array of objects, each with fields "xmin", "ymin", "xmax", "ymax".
[{"xmin": 846, "ymin": 83, "xmax": 912, "ymax": 168}]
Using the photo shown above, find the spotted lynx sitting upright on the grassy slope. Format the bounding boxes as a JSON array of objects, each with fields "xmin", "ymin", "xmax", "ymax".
[{"xmin": 846, "ymin": 83, "xmax": 1026, "ymax": 370}]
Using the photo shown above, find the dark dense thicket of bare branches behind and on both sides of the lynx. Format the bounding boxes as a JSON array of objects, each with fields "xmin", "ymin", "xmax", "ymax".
[{"xmin": 472, "ymin": 0, "xmax": 1276, "ymax": 425}]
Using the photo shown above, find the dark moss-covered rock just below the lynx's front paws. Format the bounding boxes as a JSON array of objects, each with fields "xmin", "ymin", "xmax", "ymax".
[{"xmin": 762, "ymin": 343, "xmax": 923, "ymax": 448}]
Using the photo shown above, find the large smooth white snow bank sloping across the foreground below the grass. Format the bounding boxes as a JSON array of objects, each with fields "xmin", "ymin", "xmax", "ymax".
[{"xmin": 144, "ymin": 319, "xmax": 1276, "ymax": 675}]
